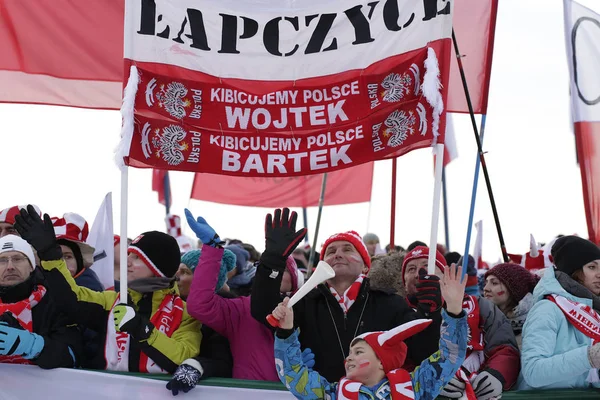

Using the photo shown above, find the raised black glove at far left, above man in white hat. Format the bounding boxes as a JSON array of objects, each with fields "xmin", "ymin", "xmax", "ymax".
[{"xmin": 15, "ymin": 204, "xmax": 62, "ymax": 261}]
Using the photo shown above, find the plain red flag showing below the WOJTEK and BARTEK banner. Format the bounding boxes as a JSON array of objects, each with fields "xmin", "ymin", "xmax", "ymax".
[{"xmin": 191, "ymin": 163, "xmax": 373, "ymax": 207}]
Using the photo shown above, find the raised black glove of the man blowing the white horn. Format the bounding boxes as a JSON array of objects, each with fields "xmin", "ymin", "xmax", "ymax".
[{"xmin": 261, "ymin": 208, "xmax": 306, "ymax": 266}]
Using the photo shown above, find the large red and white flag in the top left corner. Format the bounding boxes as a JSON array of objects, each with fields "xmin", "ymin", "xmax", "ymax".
[{"xmin": 0, "ymin": 0, "xmax": 125, "ymax": 109}]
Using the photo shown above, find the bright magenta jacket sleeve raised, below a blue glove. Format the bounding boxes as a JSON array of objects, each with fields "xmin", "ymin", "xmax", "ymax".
[{"xmin": 187, "ymin": 245, "xmax": 243, "ymax": 337}]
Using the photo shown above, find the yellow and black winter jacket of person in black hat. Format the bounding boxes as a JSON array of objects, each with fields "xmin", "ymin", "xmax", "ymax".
[{"xmin": 42, "ymin": 260, "xmax": 202, "ymax": 373}]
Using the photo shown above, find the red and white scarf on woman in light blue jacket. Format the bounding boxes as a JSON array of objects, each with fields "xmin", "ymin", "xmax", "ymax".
[{"xmin": 546, "ymin": 294, "xmax": 600, "ymax": 382}]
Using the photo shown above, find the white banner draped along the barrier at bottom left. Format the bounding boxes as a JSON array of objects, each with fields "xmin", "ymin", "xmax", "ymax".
[{"xmin": 0, "ymin": 364, "xmax": 294, "ymax": 400}]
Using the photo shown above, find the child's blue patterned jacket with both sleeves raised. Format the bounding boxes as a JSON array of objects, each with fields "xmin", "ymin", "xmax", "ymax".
[{"xmin": 275, "ymin": 310, "xmax": 468, "ymax": 400}]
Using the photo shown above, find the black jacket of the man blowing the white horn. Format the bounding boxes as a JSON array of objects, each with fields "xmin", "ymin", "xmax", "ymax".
[{"xmin": 251, "ymin": 259, "xmax": 441, "ymax": 382}]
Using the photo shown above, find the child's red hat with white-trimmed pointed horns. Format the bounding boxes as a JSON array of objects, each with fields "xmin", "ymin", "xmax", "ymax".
[{"xmin": 350, "ymin": 319, "xmax": 432, "ymax": 374}]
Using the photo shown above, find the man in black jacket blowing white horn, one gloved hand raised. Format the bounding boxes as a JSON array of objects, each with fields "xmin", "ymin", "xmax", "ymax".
[{"xmin": 251, "ymin": 208, "xmax": 441, "ymax": 382}]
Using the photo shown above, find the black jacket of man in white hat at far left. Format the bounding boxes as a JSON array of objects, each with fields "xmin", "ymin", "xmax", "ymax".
[{"xmin": 0, "ymin": 267, "xmax": 83, "ymax": 369}]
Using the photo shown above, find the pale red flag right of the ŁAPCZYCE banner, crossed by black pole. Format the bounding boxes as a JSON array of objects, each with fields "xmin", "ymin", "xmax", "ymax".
[{"xmin": 447, "ymin": 0, "xmax": 498, "ymax": 114}]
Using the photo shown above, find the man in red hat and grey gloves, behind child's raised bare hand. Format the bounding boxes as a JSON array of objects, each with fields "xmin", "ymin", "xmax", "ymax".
[{"xmin": 402, "ymin": 246, "xmax": 520, "ymax": 400}]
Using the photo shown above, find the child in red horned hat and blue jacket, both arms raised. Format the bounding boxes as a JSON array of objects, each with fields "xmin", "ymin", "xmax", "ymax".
[{"xmin": 273, "ymin": 266, "xmax": 467, "ymax": 400}]
